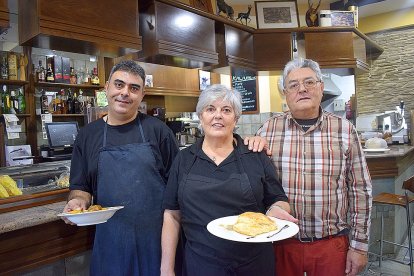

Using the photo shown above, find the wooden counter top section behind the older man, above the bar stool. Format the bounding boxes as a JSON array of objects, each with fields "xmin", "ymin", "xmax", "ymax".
[{"xmin": 365, "ymin": 145, "xmax": 414, "ymax": 179}]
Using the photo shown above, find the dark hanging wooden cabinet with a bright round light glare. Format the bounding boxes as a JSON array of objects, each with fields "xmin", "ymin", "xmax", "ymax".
[{"xmin": 138, "ymin": 0, "xmax": 218, "ymax": 68}]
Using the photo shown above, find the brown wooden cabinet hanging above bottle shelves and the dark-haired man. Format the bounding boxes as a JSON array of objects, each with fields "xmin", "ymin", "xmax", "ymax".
[{"xmin": 19, "ymin": 0, "xmax": 142, "ymax": 57}]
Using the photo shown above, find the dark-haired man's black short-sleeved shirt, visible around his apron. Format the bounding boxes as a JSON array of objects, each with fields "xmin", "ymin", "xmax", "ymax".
[{"xmin": 69, "ymin": 113, "xmax": 178, "ymax": 194}]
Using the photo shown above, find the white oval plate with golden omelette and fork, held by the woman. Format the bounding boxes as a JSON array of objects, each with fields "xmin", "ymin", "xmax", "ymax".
[{"xmin": 207, "ymin": 212, "xmax": 299, "ymax": 243}]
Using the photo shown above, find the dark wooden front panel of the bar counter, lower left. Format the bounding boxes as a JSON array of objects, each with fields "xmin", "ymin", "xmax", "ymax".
[{"xmin": 0, "ymin": 220, "xmax": 95, "ymax": 275}]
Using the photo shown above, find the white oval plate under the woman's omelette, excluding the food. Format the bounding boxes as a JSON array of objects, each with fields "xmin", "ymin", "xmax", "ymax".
[{"xmin": 207, "ymin": 216, "xmax": 299, "ymax": 242}]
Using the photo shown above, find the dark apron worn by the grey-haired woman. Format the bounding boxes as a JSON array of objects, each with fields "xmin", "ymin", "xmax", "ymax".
[{"xmin": 178, "ymin": 146, "xmax": 274, "ymax": 276}]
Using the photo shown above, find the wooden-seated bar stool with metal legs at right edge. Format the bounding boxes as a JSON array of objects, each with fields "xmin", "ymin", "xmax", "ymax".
[{"xmin": 372, "ymin": 176, "xmax": 414, "ymax": 276}]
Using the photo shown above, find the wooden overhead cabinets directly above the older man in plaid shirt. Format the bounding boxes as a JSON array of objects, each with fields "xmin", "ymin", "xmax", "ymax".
[{"xmin": 254, "ymin": 27, "xmax": 383, "ymax": 71}]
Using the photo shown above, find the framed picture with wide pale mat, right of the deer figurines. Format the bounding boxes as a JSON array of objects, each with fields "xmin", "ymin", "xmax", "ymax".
[{"xmin": 254, "ymin": 0, "xmax": 299, "ymax": 29}]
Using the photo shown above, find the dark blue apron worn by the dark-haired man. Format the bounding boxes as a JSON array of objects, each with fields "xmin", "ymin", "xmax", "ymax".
[{"xmin": 91, "ymin": 117, "xmax": 165, "ymax": 276}]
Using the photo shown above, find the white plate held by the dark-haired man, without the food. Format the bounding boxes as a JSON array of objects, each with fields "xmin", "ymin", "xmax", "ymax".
[{"xmin": 57, "ymin": 206, "xmax": 124, "ymax": 226}]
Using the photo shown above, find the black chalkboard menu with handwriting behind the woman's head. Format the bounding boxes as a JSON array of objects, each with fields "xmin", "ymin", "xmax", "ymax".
[{"xmin": 231, "ymin": 67, "xmax": 259, "ymax": 113}]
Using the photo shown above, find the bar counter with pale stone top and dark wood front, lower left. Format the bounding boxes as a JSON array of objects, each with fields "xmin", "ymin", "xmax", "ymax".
[{"xmin": 0, "ymin": 201, "xmax": 95, "ymax": 275}]
